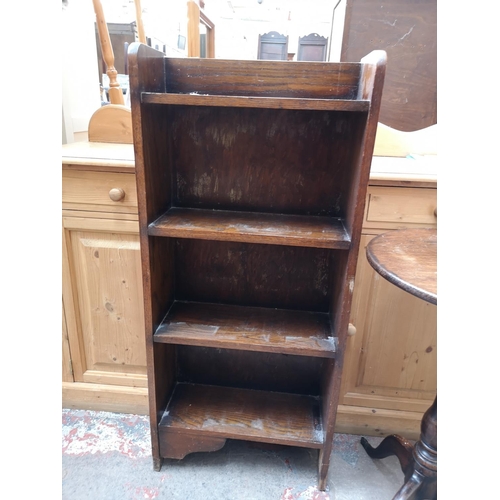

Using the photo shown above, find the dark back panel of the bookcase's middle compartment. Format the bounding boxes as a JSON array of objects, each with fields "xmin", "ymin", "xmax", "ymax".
[{"xmin": 175, "ymin": 239, "xmax": 332, "ymax": 312}]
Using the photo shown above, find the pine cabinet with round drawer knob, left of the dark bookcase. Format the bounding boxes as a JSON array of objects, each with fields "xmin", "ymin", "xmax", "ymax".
[{"xmin": 62, "ymin": 143, "xmax": 147, "ymax": 413}]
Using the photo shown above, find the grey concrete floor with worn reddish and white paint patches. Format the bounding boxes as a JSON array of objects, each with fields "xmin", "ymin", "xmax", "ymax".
[{"xmin": 62, "ymin": 410, "xmax": 403, "ymax": 500}]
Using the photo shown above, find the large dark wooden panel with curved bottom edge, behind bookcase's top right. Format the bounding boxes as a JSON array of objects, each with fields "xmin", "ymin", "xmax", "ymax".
[{"xmin": 341, "ymin": 0, "xmax": 437, "ymax": 132}]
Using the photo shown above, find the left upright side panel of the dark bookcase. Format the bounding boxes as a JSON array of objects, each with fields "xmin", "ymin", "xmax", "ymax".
[{"xmin": 128, "ymin": 43, "xmax": 175, "ymax": 467}]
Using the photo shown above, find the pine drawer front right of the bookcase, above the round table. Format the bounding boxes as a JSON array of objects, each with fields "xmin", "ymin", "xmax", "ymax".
[{"xmin": 363, "ymin": 186, "xmax": 437, "ymax": 229}]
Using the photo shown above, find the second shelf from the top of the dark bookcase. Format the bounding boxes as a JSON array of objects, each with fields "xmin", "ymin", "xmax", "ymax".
[{"xmin": 148, "ymin": 208, "xmax": 350, "ymax": 250}]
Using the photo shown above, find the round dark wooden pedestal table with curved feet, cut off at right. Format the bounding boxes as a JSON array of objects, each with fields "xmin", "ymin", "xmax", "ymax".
[{"xmin": 361, "ymin": 229, "xmax": 437, "ymax": 500}]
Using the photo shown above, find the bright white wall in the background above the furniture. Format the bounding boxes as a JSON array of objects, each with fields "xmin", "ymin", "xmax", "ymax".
[{"xmin": 60, "ymin": 0, "xmax": 346, "ymax": 142}]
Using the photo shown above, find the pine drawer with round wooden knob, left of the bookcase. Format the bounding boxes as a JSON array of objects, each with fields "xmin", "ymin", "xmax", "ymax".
[{"xmin": 62, "ymin": 170, "xmax": 141, "ymax": 214}]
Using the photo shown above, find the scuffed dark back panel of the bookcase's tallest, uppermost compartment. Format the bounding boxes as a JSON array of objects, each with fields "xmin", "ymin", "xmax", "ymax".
[{"xmin": 168, "ymin": 106, "xmax": 364, "ymax": 217}]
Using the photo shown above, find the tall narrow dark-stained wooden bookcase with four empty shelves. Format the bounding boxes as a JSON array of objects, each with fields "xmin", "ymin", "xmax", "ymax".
[{"xmin": 129, "ymin": 44, "xmax": 385, "ymax": 489}]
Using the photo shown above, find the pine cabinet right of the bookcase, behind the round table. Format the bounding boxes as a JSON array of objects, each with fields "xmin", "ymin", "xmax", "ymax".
[{"xmin": 336, "ymin": 178, "xmax": 437, "ymax": 439}]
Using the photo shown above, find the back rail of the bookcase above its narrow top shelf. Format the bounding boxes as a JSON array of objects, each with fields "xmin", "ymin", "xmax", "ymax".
[{"xmin": 141, "ymin": 56, "xmax": 376, "ymax": 100}]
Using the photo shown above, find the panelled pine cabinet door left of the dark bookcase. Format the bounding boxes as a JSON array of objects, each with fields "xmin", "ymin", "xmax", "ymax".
[{"xmin": 63, "ymin": 217, "xmax": 147, "ymax": 388}]
